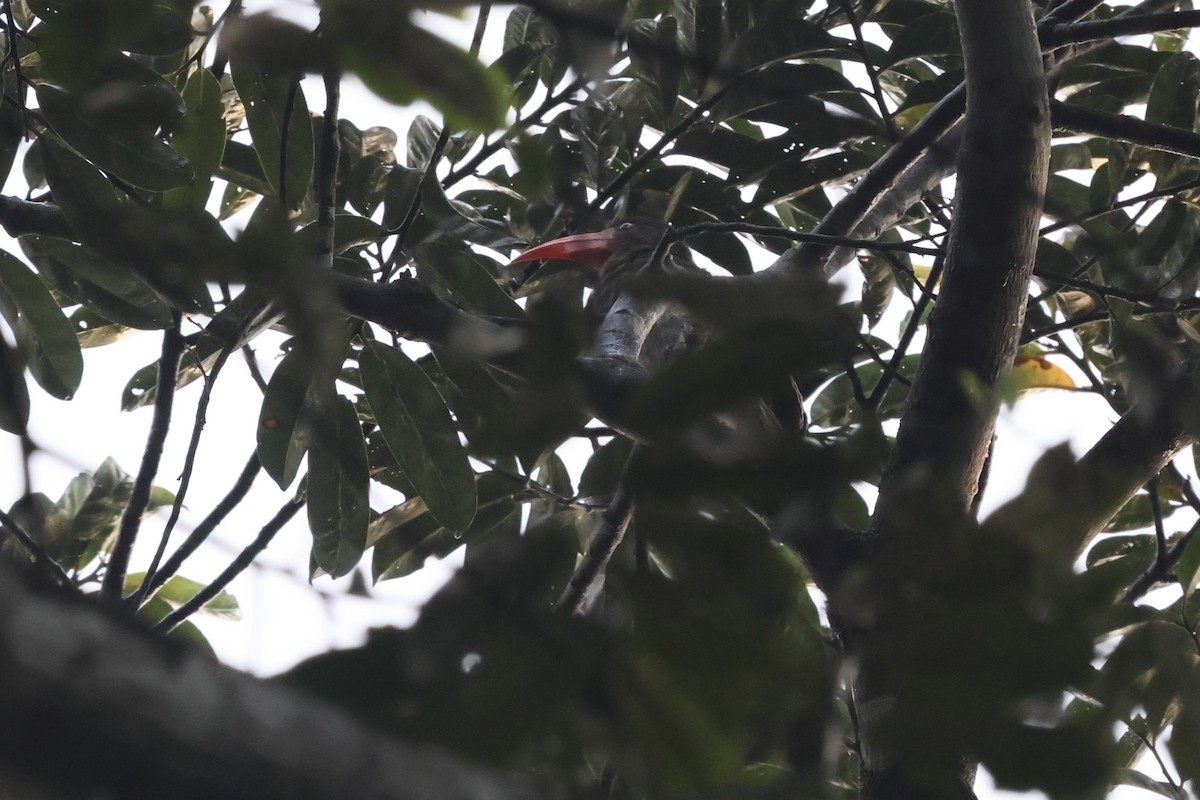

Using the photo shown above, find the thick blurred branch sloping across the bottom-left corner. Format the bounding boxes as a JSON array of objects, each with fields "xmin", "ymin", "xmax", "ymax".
[{"xmin": 0, "ymin": 565, "xmax": 559, "ymax": 800}]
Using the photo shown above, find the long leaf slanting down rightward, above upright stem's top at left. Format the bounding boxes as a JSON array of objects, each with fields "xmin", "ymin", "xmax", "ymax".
[{"xmin": 18, "ymin": 235, "xmax": 170, "ymax": 330}]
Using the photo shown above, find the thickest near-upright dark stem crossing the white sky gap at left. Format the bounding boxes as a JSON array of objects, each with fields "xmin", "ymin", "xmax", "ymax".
[{"xmin": 100, "ymin": 311, "xmax": 184, "ymax": 602}]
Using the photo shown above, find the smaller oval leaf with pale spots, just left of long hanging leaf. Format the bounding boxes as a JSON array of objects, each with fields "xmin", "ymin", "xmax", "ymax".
[{"xmin": 258, "ymin": 349, "xmax": 312, "ymax": 489}]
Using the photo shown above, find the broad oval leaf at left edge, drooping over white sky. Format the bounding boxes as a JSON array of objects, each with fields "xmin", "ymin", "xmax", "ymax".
[{"xmin": 0, "ymin": 251, "xmax": 83, "ymax": 399}]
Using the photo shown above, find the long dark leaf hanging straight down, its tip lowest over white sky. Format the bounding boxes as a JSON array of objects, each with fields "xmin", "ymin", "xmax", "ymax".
[{"xmin": 307, "ymin": 395, "xmax": 371, "ymax": 578}]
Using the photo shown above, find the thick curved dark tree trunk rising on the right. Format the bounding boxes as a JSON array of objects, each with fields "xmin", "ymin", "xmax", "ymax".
[{"xmin": 850, "ymin": 0, "xmax": 1051, "ymax": 800}]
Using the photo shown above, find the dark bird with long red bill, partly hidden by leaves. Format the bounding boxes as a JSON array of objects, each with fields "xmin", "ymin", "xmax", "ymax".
[{"xmin": 512, "ymin": 218, "xmax": 803, "ymax": 463}]
